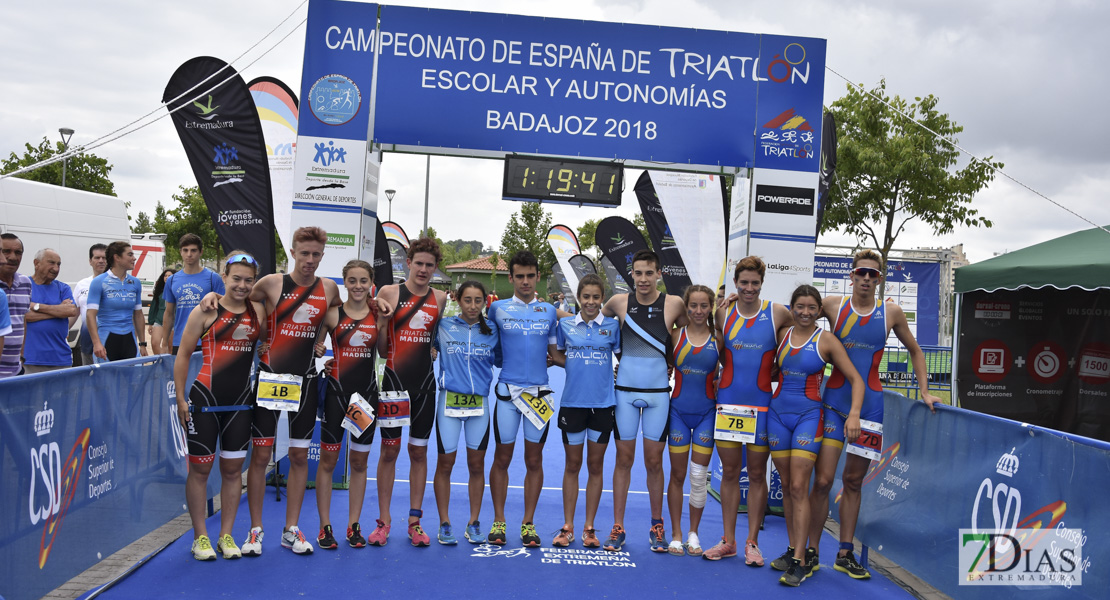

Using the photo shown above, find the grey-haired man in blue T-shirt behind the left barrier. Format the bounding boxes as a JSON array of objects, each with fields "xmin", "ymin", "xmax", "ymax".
[{"xmin": 23, "ymin": 248, "xmax": 80, "ymax": 374}]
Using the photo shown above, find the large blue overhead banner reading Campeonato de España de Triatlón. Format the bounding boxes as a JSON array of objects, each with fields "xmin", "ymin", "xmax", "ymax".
[{"xmin": 368, "ymin": 5, "xmax": 825, "ymax": 172}]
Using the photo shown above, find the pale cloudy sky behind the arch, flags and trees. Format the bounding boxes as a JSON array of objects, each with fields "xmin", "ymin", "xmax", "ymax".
[{"xmin": 0, "ymin": 0, "xmax": 1110, "ymax": 261}]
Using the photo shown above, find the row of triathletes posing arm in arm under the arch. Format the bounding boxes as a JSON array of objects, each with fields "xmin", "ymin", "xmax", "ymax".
[{"xmin": 174, "ymin": 227, "xmax": 938, "ymax": 587}]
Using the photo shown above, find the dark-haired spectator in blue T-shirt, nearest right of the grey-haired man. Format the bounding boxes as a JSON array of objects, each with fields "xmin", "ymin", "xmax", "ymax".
[{"xmin": 85, "ymin": 242, "xmax": 150, "ymax": 363}]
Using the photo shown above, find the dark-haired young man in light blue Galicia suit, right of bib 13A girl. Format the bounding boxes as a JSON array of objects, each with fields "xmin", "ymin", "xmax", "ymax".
[{"xmin": 488, "ymin": 251, "xmax": 557, "ymax": 548}]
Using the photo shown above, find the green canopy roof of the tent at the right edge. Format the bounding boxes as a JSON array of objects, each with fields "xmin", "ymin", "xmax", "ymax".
[{"xmin": 956, "ymin": 225, "xmax": 1110, "ymax": 294}]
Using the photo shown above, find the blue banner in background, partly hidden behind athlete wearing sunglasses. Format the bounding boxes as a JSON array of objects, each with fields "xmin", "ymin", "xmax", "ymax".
[{"xmin": 814, "ymin": 255, "xmax": 940, "ymax": 346}]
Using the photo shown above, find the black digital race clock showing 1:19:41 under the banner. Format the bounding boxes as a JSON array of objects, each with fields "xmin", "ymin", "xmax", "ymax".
[{"xmin": 502, "ymin": 155, "xmax": 624, "ymax": 206}]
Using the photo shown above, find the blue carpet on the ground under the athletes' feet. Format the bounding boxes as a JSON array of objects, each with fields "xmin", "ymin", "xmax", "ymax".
[{"xmin": 86, "ymin": 369, "xmax": 910, "ymax": 600}]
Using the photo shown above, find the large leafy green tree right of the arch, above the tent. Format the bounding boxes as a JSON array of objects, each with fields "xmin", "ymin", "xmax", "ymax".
[{"xmin": 821, "ymin": 80, "xmax": 1002, "ymax": 270}]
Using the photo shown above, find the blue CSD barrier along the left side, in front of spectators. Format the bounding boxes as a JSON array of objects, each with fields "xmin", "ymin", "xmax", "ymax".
[{"xmin": 0, "ymin": 353, "xmax": 199, "ymax": 600}]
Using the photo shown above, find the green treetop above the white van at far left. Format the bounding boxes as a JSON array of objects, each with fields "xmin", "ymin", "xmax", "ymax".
[{"xmin": 0, "ymin": 136, "xmax": 115, "ymax": 196}]
